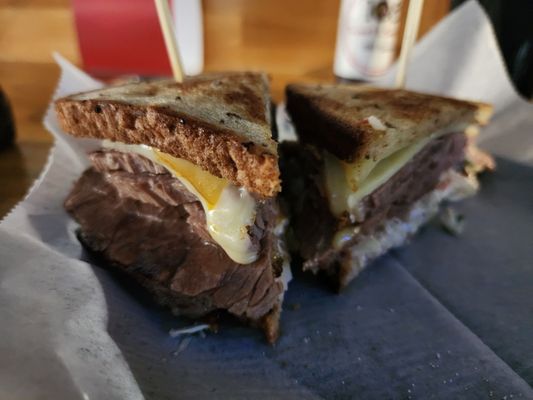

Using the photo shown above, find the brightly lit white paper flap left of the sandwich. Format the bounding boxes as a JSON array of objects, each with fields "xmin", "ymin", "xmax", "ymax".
[{"xmin": 0, "ymin": 56, "xmax": 142, "ymax": 400}]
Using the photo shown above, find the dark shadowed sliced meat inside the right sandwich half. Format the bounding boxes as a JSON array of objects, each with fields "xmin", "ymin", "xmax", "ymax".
[{"xmin": 280, "ymin": 133, "xmax": 466, "ymax": 274}]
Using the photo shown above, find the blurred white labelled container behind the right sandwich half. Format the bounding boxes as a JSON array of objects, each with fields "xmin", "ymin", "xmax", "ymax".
[{"xmin": 334, "ymin": 0, "xmax": 402, "ymax": 80}]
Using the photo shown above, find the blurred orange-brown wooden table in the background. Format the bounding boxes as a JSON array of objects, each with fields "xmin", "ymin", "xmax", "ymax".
[{"xmin": 0, "ymin": 0, "xmax": 449, "ymax": 217}]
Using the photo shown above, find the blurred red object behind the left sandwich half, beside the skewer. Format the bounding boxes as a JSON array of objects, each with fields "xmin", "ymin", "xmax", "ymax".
[{"xmin": 72, "ymin": 0, "xmax": 171, "ymax": 77}]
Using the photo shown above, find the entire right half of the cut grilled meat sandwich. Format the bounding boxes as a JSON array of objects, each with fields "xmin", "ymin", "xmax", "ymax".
[{"xmin": 281, "ymin": 84, "xmax": 493, "ymax": 288}]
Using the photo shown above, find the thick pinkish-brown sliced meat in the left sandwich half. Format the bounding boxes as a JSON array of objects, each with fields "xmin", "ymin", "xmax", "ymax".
[{"xmin": 65, "ymin": 151, "xmax": 284, "ymax": 340}]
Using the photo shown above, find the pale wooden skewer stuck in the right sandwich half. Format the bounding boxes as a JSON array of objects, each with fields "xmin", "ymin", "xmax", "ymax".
[{"xmin": 395, "ymin": 0, "xmax": 424, "ymax": 88}]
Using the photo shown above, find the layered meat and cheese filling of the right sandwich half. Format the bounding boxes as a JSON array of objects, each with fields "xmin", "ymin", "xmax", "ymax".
[{"xmin": 282, "ymin": 131, "xmax": 478, "ymax": 286}]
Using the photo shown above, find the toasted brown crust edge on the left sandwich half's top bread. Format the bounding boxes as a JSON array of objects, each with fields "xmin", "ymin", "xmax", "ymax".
[{"xmin": 55, "ymin": 98, "xmax": 281, "ymax": 197}]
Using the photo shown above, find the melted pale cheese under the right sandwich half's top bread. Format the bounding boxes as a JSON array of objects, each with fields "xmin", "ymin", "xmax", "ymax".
[{"xmin": 324, "ymin": 125, "xmax": 466, "ymax": 222}]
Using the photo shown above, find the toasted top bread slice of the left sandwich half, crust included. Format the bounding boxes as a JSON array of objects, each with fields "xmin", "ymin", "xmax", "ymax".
[{"xmin": 55, "ymin": 72, "xmax": 281, "ymax": 197}]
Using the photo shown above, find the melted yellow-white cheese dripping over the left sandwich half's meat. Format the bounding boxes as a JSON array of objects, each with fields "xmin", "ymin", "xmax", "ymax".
[{"xmin": 104, "ymin": 141, "xmax": 258, "ymax": 264}]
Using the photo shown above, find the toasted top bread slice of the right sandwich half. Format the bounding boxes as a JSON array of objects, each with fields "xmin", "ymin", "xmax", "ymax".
[{"xmin": 286, "ymin": 84, "xmax": 492, "ymax": 163}]
